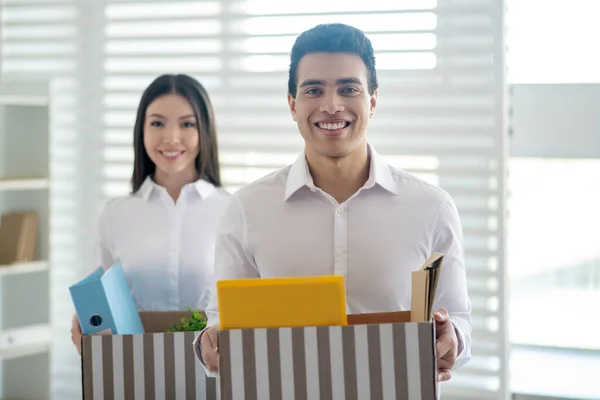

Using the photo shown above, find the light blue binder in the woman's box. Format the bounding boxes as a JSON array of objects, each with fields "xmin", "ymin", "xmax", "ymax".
[{"xmin": 69, "ymin": 262, "xmax": 144, "ymax": 335}]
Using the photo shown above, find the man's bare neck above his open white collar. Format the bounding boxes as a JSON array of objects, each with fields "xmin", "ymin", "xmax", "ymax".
[{"xmin": 306, "ymin": 144, "xmax": 370, "ymax": 204}]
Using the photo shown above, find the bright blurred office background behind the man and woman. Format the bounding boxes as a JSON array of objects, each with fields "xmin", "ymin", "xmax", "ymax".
[{"xmin": 0, "ymin": 0, "xmax": 600, "ymax": 400}]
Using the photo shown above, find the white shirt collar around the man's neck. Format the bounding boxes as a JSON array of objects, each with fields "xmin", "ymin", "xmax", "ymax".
[{"xmin": 284, "ymin": 143, "xmax": 400, "ymax": 201}]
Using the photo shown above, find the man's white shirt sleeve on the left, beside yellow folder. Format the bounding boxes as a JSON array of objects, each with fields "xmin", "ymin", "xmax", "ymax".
[{"xmin": 194, "ymin": 196, "xmax": 260, "ymax": 376}]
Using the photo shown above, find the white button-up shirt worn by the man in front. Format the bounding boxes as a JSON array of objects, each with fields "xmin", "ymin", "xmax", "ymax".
[{"xmin": 203, "ymin": 145, "xmax": 471, "ymax": 368}]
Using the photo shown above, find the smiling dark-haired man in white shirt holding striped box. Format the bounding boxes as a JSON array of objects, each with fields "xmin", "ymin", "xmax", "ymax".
[{"xmin": 195, "ymin": 24, "xmax": 471, "ymax": 381}]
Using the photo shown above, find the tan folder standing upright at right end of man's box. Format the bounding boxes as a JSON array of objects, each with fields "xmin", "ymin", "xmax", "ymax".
[{"xmin": 410, "ymin": 253, "xmax": 444, "ymax": 322}]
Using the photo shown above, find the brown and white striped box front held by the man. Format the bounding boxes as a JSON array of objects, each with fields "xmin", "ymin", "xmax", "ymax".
[{"xmin": 219, "ymin": 323, "xmax": 438, "ymax": 400}]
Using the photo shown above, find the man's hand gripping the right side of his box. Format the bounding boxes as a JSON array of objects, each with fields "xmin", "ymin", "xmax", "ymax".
[{"xmin": 433, "ymin": 308, "xmax": 458, "ymax": 382}]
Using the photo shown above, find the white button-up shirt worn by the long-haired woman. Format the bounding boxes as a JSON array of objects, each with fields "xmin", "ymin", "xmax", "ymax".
[{"xmin": 97, "ymin": 178, "xmax": 231, "ymax": 311}]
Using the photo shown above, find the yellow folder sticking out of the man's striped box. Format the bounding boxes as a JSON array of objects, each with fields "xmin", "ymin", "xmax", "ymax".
[{"xmin": 217, "ymin": 275, "xmax": 347, "ymax": 330}]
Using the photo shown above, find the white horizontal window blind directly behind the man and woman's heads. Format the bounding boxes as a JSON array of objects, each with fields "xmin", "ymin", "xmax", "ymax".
[{"xmin": 99, "ymin": 0, "xmax": 508, "ymax": 400}]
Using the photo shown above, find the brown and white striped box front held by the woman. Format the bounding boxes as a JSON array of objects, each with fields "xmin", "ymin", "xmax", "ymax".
[{"xmin": 83, "ymin": 332, "xmax": 219, "ymax": 400}]
